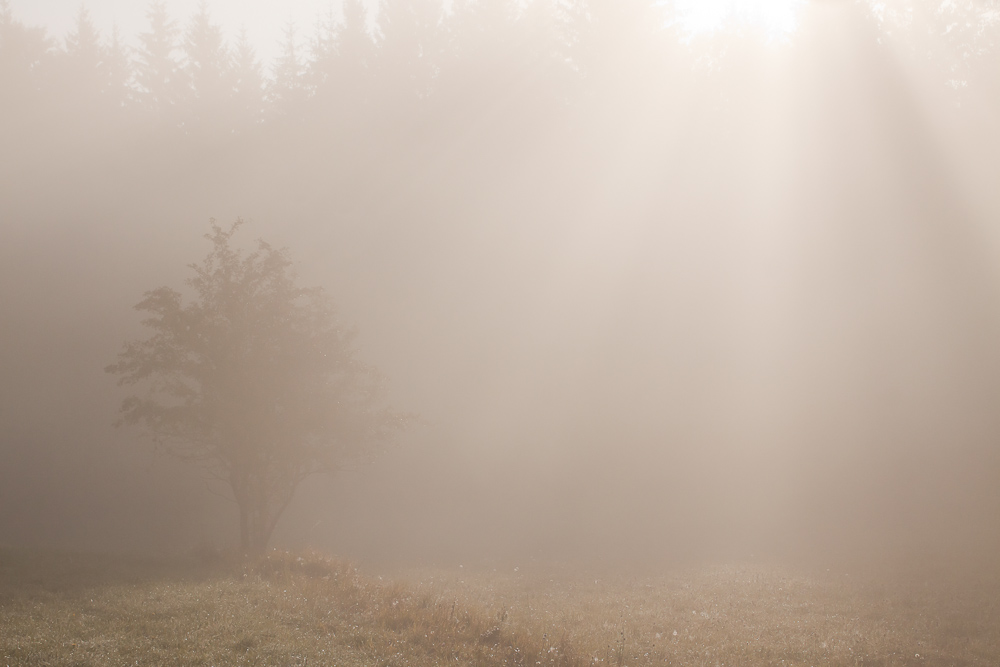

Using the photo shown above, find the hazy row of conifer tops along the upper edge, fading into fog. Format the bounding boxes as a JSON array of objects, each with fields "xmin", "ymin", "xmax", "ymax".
[{"xmin": 0, "ymin": 0, "xmax": 1000, "ymax": 145}]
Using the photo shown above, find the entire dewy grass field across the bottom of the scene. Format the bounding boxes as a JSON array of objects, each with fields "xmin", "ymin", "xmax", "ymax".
[{"xmin": 0, "ymin": 550, "xmax": 1000, "ymax": 667}]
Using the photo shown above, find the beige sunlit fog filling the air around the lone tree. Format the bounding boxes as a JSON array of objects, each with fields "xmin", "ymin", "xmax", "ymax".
[{"xmin": 0, "ymin": 0, "xmax": 1000, "ymax": 566}]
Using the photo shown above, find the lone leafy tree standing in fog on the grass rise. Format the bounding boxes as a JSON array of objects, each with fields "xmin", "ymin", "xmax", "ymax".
[{"xmin": 105, "ymin": 220, "xmax": 410, "ymax": 555}]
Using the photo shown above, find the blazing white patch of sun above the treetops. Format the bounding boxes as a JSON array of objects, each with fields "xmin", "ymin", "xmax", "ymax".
[{"xmin": 674, "ymin": 0, "xmax": 805, "ymax": 39}]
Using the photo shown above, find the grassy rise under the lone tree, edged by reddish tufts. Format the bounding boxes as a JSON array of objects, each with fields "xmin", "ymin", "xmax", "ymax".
[{"xmin": 0, "ymin": 551, "xmax": 578, "ymax": 667}]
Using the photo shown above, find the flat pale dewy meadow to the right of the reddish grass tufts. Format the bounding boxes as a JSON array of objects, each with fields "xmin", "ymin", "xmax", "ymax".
[{"xmin": 394, "ymin": 566, "xmax": 1000, "ymax": 667}]
